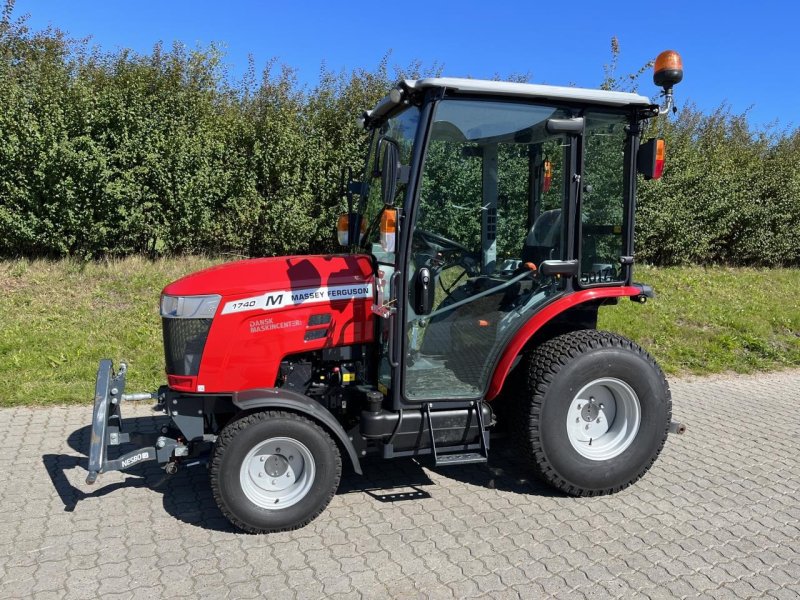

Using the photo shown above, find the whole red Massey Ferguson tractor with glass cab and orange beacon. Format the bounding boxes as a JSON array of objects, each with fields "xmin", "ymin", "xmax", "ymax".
[{"xmin": 87, "ymin": 51, "xmax": 682, "ymax": 532}]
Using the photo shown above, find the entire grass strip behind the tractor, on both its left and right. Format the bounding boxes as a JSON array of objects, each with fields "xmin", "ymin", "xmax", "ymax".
[{"xmin": 0, "ymin": 258, "xmax": 800, "ymax": 406}]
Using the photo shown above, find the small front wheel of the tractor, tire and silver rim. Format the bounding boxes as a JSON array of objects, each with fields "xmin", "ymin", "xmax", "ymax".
[{"xmin": 210, "ymin": 411, "xmax": 342, "ymax": 533}]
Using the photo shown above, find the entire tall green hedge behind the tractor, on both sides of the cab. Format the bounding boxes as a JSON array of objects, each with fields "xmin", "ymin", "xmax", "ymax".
[{"xmin": 0, "ymin": 3, "xmax": 800, "ymax": 265}]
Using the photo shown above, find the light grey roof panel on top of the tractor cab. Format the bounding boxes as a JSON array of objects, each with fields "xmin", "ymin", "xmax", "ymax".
[{"xmin": 401, "ymin": 77, "xmax": 653, "ymax": 107}]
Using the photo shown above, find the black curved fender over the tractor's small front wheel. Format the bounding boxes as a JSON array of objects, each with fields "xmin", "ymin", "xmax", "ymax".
[{"xmin": 233, "ymin": 388, "xmax": 363, "ymax": 475}]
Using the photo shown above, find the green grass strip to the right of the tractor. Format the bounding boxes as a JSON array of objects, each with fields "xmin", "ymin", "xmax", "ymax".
[{"xmin": 598, "ymin": 266, "xmax": 800, "ymax": 375}]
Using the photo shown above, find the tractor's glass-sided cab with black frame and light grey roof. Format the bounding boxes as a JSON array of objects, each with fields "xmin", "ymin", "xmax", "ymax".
[{"xmin": 343, "ymin": 78, "xmax": 658, "ymax": 409}]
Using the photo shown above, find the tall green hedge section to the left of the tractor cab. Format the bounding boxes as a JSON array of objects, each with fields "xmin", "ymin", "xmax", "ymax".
[{"xmin": 0, "ymin": 3, "xmax": 400, "ymax": 258}]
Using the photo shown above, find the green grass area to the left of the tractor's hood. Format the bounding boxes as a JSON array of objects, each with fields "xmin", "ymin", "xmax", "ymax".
[{"xmin": 0, "ymin": 258, "xmax": 213, "ymax": 406}]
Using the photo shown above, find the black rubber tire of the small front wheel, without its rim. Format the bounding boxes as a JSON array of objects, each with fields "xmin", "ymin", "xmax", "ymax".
[{"xmin": 210, "ymin": 410, "xmax": 342, "ymax": 533}]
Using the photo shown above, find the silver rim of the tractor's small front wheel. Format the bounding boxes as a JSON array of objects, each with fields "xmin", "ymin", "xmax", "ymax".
[{"xmin": 239, "ymin": 437, "xmax": 316, "ymax": 510}]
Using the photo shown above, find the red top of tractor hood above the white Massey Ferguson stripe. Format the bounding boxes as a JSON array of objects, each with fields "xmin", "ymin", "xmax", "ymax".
[{"xmin": 162, "ymin": 254, "xmax": 372, "ymax": 297}]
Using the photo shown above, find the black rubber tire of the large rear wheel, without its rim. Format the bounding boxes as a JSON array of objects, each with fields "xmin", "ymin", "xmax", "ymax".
[{"xmin": 517, "ymin": 329, "xmax": 672, "ymax": 496}]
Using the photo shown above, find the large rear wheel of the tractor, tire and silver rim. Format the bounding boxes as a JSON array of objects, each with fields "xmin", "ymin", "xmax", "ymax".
[{"xmin": 520, "ymin": 330, "xmax": 672, "ymax": 496}]
